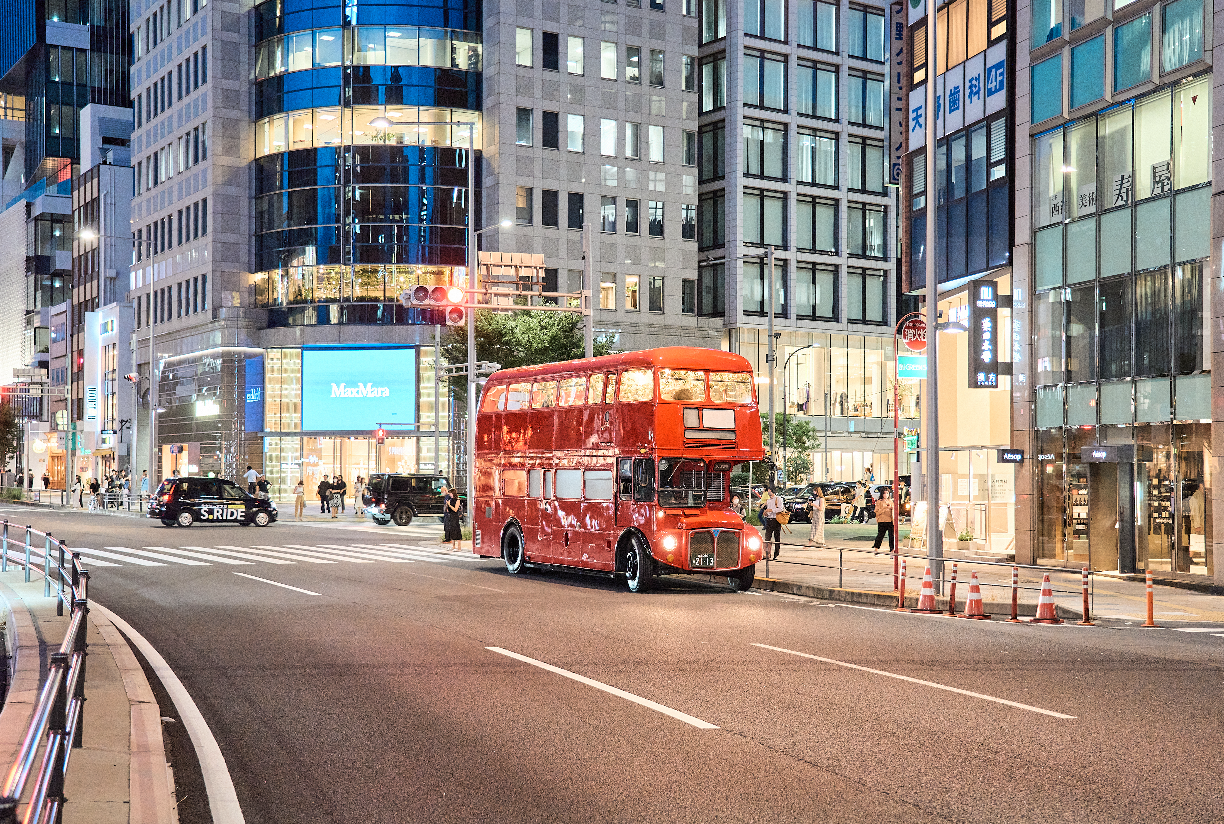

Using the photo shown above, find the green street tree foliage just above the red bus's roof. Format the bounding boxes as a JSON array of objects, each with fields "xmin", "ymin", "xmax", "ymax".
[{"xmin": 442, "ymin": 310, "xmax": 612, "ymax": 394}]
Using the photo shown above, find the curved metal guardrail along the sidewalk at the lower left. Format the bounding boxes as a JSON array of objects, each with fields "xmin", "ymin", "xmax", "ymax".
[{"xmin": 0, "ymin": 520, "xmax": 89, "ymax": 824}]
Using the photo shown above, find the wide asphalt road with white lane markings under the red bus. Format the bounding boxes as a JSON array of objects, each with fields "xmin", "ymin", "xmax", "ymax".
[{"xmin": 0, "ymin": 508, "xmax": 1224, "ymax": 824}]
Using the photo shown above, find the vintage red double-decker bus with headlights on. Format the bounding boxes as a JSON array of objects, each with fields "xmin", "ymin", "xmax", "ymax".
[{"xmin": 470, "ymin": 346, "xmax": 765, "ymax": 593}]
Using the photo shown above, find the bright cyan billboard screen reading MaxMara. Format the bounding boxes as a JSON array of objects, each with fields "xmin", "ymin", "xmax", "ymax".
[{"xmin": 302, "ymin": 348, "xmax": 416, "ymax": 431}]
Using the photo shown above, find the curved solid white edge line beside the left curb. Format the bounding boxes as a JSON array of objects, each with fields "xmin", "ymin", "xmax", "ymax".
[{"xmin": 89, "ymin": 600, "xmax": 246, "ymax": 824}]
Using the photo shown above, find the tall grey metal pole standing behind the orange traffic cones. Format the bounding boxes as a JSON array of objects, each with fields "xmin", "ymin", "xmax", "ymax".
[{"xmin": 923, "ymin": 2, "xmax": 944, "ymax": 585}]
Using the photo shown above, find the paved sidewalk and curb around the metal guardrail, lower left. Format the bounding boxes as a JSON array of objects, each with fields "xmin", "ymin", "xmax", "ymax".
[{"xmin": 0, "ymin": 564, "xmax": 179, "ymax": 824}]
